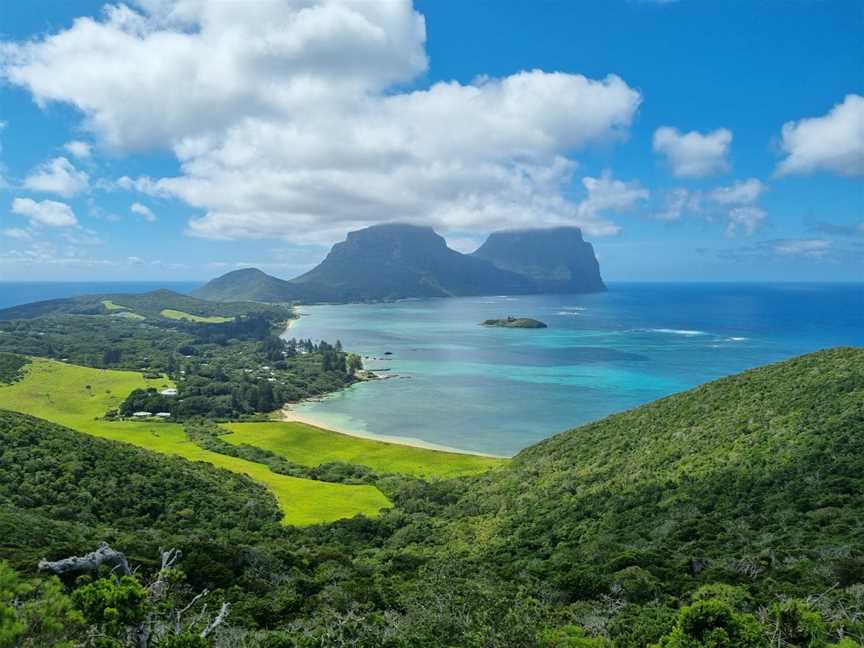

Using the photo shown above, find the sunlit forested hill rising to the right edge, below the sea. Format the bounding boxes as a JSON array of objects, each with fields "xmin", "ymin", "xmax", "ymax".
[{"xmin": 456, "ymin": 348, "xmax": 864, "ymax": 601}]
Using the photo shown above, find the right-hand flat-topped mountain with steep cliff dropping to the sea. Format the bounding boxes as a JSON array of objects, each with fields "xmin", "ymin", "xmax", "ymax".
[{"xmin": 471, "ymin": 227, "xmax": 606, "ymax": 293}]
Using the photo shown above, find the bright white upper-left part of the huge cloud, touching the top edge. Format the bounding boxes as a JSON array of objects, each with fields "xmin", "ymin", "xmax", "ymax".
[{"xmin": 0, "ymin": 0, "xmax": 427, "ymax": 149}]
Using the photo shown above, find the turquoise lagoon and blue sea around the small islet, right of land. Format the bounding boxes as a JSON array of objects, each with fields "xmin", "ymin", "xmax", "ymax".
[{"xmin": 289, "ymin": 284, "xmax": 864, "ymax": 455}]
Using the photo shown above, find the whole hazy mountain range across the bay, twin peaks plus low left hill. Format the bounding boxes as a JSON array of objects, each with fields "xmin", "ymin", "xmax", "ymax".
[{"xmin": 194, "ymin": 224, "xmax": 606, "ymax": 302}]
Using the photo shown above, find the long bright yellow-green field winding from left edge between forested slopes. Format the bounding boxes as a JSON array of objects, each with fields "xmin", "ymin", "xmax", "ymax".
[{"xmin": 0, "ymin": 358, "xmax": 391, "ymax": 526}]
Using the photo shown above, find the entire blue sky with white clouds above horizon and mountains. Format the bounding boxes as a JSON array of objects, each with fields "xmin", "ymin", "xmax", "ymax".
[{"xmin": 0, "ymin": 0, "xmax": 864, "ymax": 281}]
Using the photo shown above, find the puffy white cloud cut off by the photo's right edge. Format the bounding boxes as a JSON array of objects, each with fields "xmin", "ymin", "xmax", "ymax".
[{"xmin": 777, "ymin": 94, "xmax": 864, "ymax": 176}]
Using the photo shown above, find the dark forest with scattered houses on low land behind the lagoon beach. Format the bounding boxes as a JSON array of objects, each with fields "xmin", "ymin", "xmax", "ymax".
[{"xmin": 0, "ymin": 302, "xmax": 362, "ymax": 420}]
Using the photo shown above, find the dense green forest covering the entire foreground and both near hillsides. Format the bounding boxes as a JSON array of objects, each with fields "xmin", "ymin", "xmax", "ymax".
[{"xmin": 0, "ymin": 349, "xmax": 864, "ymax": 648}]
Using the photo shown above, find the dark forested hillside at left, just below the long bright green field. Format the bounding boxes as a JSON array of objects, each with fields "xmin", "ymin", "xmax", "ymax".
[{"xmin": 0, "ymin": 411, "xmax": 281, "ymax": 567}]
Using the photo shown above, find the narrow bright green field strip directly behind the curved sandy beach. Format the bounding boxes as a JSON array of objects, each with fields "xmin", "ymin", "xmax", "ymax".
[{"xmin": 222, "ymin": 421, "xmax": 506, "ymax": 477}]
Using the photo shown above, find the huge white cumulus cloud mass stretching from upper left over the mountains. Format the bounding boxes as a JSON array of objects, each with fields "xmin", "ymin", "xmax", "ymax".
[{"xmin": 0, "ymin": 0, "xmax": 644, "ymax": 242}]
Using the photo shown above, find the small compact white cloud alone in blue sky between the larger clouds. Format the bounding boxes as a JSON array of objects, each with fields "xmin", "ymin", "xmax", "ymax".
[{"xmin": 654, "ymin": 126, "xmax": 732, "ymax": 178}]
